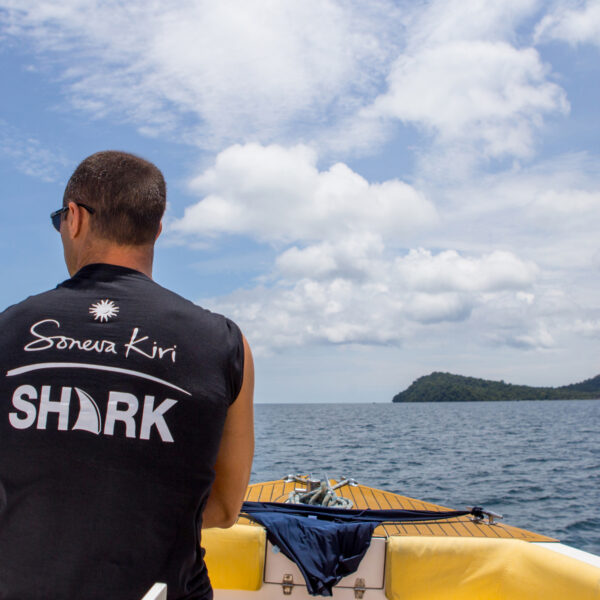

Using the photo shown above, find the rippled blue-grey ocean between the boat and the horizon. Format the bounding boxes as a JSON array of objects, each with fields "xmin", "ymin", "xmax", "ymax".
[{"xmin": 251, "ymin": 400, "xmax": 600, "ymax": 555}]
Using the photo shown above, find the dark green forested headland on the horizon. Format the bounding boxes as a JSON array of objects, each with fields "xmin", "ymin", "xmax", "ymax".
[{"xmin": 392, "ymin": 372, "xmax": 600, "ymax": 402}]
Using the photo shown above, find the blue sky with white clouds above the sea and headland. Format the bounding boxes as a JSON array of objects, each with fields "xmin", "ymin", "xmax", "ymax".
[{"xmin": 0, "ymin": 0, "xmax": 600, "ymax": 402}]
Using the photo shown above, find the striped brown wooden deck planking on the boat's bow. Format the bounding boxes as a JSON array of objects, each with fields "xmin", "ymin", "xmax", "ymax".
[{"xmin": 238, "ymin": 480, "xmax": 557, "ymax": 542}]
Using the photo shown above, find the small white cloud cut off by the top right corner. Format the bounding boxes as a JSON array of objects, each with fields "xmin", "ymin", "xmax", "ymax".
[{"xmin": 535, "ymin": 0, "xmax": 600, "ymax": 46}]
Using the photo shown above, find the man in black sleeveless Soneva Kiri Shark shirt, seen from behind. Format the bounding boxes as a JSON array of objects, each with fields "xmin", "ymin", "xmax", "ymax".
[{"xmin": 0, "ymin": 152, "xmax": 254, "ymax": 600}]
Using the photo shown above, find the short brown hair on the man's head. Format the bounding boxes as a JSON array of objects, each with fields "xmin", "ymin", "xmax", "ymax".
[{"xmin": 63, "ymin": 150, "xmax": 167, "ymax": 245}]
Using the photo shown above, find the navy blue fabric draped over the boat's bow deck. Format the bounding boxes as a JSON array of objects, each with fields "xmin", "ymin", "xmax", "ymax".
[{"xmin": 242, "ymin": 502, "xmax": 469, "ymax": 596}]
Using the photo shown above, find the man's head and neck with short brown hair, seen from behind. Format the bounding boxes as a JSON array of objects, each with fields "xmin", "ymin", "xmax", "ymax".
[{"xmin": 60, "ymin": 150, "xmax": 166, "ymax": 272}]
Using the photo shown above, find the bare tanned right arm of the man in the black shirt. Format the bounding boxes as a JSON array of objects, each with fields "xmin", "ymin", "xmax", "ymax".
[{"xmin": 202, "ymin": 338, "xmax": 254, "ymax": 529}]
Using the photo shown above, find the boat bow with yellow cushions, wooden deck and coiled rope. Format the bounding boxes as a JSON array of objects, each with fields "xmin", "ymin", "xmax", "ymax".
[{"xmin": 202, "ymin": 475, "xmax": 600, "ymax": 600}]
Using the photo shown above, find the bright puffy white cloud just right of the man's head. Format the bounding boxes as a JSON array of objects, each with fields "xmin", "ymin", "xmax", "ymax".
[{"xmin": 172, "ymin": 144, "xmax": 436, "ymax": 242}]
